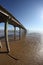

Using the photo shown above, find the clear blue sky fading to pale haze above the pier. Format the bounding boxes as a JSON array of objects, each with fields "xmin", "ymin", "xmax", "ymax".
[{"xmin": 0, "ymin": 0, "xmax": 43, "ymax": 31}]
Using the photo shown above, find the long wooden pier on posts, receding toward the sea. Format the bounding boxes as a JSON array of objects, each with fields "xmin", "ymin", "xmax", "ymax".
[{"xmin": 0, "ymin": 6, "xmax": 26, "ymax": 53}]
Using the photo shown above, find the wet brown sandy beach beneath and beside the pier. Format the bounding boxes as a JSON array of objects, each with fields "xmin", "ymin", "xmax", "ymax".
[{"xmin": 0, "ymin": 33, "xmax": 43, "ymax": 65}]
